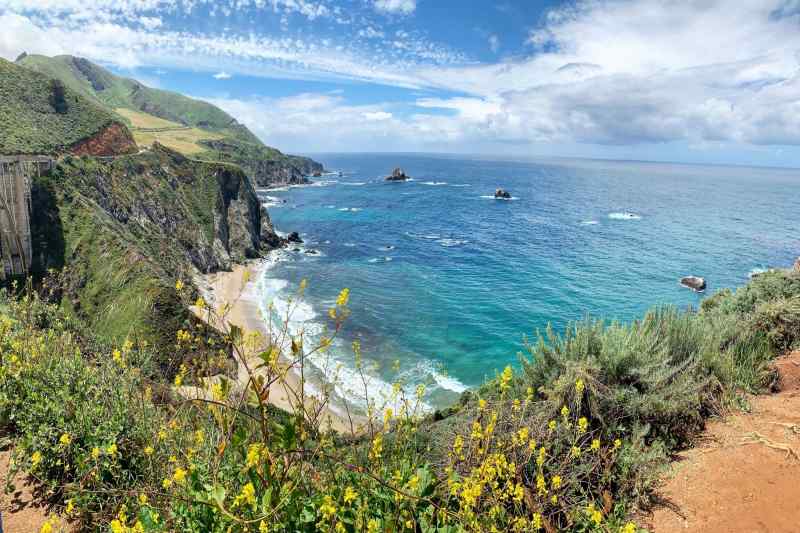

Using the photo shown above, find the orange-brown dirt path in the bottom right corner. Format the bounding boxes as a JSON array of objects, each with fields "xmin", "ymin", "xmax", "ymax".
[{"xmin": 650, "ymin": 351, "xmax": 800, "ymax": 533}]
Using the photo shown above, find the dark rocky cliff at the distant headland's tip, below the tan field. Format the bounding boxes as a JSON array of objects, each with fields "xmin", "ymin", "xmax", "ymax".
[{"xmin": 197, "ymin": 139, "xmax": 324, "ymax": 187}]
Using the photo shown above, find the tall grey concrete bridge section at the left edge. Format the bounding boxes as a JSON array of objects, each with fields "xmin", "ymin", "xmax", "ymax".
[{"xmin": 0, "ymin": 155, "xmax": 54, "ymax": 279}]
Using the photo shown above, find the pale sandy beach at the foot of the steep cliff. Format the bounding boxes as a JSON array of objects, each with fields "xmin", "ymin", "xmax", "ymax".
[{"xmin": 192, "ymin": 259, "xmax": 356, "ymax": 433}]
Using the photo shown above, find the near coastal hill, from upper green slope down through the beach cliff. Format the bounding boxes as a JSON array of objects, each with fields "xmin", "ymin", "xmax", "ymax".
[{"xmin": 0, "ymin": 57, "xmax": 281, "ymax": 352}]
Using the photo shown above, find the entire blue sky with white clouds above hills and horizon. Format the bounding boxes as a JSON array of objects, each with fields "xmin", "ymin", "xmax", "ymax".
[{"xmin": 0, "ymin": 0, "xmax": 800, "ymax": 167}]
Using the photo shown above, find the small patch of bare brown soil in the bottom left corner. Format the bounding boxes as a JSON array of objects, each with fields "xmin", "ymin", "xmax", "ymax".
[{"xmin": 0, "ymin": 450, "xmax": 69, "ymax": 533}]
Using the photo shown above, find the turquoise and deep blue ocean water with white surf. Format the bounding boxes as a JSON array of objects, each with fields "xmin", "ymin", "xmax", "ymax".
[{"xmin": 253, "ymin": 154, "xmax": 800, "ymax": 405}]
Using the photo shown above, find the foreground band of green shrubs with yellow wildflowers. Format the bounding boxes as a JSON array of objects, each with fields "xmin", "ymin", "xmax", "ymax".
[{"xmin": 0, "ymin": 264, "xmax": 800, "ymax": 533}]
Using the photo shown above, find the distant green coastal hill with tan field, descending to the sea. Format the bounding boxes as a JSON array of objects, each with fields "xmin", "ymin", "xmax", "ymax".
[{"xmin": 17, "ymin": 54, "xmax": 322, "ymax": 187}]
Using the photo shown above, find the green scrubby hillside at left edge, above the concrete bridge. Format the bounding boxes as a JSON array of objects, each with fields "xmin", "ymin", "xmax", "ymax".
[{"xmin": 0, "ymin": 59, "xmax": 117, "ymax": 154}]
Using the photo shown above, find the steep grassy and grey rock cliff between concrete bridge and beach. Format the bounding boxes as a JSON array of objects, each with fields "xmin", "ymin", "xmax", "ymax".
[{"xmin": 32, "ymin": 146, "xmax": 281, "ymax": 346}]
